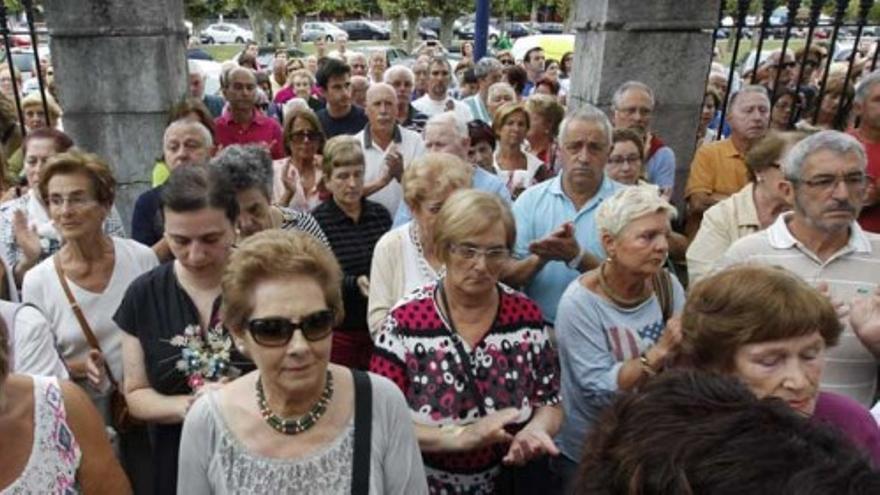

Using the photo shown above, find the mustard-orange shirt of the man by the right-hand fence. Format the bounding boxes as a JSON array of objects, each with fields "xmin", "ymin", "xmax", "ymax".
[{"xmin": 685, "ymin": 139, "xmax": 749, "ymax": 197}]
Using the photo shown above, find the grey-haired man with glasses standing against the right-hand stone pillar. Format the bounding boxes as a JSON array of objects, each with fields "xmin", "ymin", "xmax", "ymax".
[{"xmin": 611, "ymin": 81, "xmax": 675, "ymax": 194}]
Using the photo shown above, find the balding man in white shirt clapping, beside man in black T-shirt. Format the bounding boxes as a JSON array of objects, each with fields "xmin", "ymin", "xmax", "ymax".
[{"xmin": 355, "ymin": 83, "xmax": 425, "ymax": 215}]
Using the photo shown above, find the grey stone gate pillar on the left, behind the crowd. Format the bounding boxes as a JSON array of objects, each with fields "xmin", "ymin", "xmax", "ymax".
[{"xmin": 43, "ymin": 0, "xmax": 187, "ymax": 234}]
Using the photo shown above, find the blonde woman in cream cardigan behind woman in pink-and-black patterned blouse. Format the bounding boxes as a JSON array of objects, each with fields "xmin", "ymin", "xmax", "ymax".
[{"xmin": 368, "ymin": 153, "xmax": 473, "ymax": 336}]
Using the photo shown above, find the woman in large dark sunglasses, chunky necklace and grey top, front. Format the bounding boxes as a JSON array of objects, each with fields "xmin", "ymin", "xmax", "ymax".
[{"xmin": 177, "ymin": 231, "xmax": 427, "ymax": 495}]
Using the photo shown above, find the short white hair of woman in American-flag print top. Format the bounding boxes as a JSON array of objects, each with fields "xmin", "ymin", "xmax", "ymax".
[{"xmin": 596, "ymin": 184, "xmax": 676, "ymax": 237}]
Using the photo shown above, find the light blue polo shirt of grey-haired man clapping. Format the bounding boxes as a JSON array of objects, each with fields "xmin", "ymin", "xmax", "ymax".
[{"xmin": 513, "ymin": 174, "xmax": 623, "ymax": 324}]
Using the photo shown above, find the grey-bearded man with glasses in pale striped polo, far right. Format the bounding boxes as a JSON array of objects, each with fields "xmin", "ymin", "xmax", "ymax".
[{"xmin": 716, "ymin": 131, "xmax": 880, "ymax": 407}]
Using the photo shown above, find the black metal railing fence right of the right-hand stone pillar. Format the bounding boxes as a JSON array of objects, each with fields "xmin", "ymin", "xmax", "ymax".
[{"xmin": 713, "ymin": 0, "xmax": 880, "ymax": 139}]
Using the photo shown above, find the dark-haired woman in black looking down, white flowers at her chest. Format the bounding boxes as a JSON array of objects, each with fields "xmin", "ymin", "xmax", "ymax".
[{"xmin": 113, "ymin": 166, "xmax": 253, "ymax": 494}]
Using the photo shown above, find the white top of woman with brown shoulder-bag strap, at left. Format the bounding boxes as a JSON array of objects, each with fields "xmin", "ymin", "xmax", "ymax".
[{"xmin": 21, "ymin": 237, "xmax": 159, "ymax": 383}]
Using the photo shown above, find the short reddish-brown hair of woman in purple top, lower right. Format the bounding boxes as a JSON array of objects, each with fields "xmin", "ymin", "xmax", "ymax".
[{"xmin": 679, "ymin": 264, "xmax": 843, "ymax": 372}]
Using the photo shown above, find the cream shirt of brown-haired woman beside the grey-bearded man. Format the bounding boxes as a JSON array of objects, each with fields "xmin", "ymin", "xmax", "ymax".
[{"xmin": 687, "ymin": 182, "xmax": 761, "ymax": 283}]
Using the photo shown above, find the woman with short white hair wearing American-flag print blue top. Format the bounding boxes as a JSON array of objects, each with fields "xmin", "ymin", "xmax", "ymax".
[{"xmin": 555, "ymin": 186, "xmax": 685, "ymax": 485}]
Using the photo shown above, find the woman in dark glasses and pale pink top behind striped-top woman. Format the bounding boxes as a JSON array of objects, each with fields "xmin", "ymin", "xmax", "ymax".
[{"xmin": 272, "ymin": 109, "xmax": 326, "ymax": 212}]
